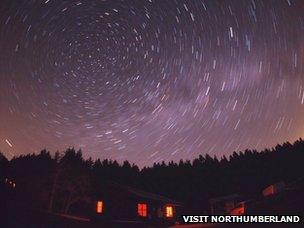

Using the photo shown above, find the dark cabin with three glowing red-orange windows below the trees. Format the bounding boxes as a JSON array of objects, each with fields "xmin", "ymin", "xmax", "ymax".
[{"xmin": 93, "ymin": 183, "xmax": 181, "ymax": 225}]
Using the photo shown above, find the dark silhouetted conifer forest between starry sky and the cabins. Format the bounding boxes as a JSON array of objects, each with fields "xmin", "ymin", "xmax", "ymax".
[{"xmin": 0, "ymin": 138, "xmax": 304, "ymax": 213}]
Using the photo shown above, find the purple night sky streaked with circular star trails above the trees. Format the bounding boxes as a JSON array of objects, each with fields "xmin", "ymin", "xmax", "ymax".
[{"xmin": 0, "ymin": 0, "xmax": 304, "ymax": 166}]
